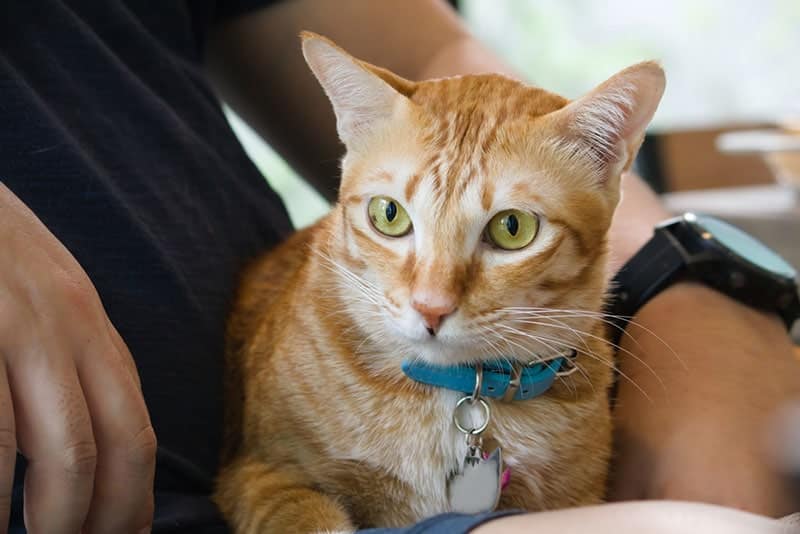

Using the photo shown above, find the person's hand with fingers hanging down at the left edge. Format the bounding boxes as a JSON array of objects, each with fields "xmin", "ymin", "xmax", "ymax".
[{"xmin": 0, "ymin": 183, "xmax": 156, "ymax": 533}]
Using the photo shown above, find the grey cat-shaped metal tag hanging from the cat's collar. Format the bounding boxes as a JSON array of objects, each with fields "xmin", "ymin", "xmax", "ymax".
[{"xmin": 447, "ymin": 445, "xmax": 503, "ymax": 514}]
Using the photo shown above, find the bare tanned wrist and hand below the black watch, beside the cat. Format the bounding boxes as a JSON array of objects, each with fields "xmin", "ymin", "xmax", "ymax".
[{"xmin": 610, "ymin": 284, "xmax": 800, "ymax": 517}]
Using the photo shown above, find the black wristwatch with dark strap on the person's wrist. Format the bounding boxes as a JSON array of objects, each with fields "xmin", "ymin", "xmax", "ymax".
[{"xmin": 608, "ymin": 213, "xmax": 800, "ymax": 343}]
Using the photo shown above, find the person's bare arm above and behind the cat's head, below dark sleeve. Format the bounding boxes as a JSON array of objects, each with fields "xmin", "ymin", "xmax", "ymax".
[{"xmin": 207, "ymin": 0, "xmax": 476, "ymax": 200}]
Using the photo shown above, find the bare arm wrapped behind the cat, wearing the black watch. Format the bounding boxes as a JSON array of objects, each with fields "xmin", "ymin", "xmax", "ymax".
[{"xmin": 209, "ymin": 0, "xmax": 800, "ymax": 514}]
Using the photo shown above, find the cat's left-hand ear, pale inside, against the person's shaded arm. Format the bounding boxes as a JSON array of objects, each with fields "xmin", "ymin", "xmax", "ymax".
[{"xmin": 300, "ymin": 32, "xmax": 414, "ymax": 149}]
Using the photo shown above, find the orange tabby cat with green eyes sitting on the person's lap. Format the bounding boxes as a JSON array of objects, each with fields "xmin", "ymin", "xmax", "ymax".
[{"xmin": 215, "ymin": 33, "xmax": 664, "ymax": 533}]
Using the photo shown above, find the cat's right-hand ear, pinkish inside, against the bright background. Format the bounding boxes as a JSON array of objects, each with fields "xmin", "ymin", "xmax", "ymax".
[{"xmin": 557, "ymin": 61, "xmax": 666, "ymax": 181}]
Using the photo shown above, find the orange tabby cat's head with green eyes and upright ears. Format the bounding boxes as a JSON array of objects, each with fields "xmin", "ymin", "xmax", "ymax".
[{"xmin": 303, "ymin": 33, "xmax": 664, "ymax": 364}]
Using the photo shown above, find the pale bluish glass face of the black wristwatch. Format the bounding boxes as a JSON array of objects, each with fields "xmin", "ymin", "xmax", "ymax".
[{"xmin": 686, "ymin": 214, "xmax": 797, "ymax": 280}]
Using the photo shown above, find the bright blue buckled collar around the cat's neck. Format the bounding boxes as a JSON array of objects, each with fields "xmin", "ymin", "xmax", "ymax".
[{"xmin": 401, "ymin": 356, "xmax": 567, "ymax": 400}]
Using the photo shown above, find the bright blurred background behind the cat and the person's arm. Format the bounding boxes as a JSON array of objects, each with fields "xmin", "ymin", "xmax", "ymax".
[{"xmin": 225, "ymin": 0, "xmax": 800, "ymax": 339}]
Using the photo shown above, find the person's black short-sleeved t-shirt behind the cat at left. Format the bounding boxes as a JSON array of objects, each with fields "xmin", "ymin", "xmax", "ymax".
[{"xmin": 0, "ymin": 0, "xmax": 299, "ymax": 532}]
